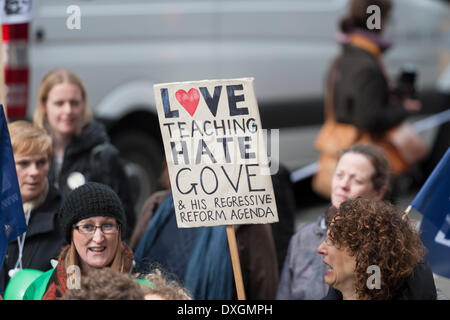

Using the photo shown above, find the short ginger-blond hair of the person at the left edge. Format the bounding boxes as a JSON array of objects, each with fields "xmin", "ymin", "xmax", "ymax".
[{"xmin": 8, "ymin": 120, "xmax": 52, "ymax": 160}]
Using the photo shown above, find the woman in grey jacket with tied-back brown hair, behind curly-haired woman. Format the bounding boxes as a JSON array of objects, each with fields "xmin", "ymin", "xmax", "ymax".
[{"xmin": 277, "ymin": 144, "xmax": 390, "ymax": 300}]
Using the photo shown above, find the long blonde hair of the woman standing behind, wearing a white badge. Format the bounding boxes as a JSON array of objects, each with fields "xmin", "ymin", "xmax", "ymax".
[{"xmin": 33, "ymin": 69, "xmax": 92, "ymax": 134}]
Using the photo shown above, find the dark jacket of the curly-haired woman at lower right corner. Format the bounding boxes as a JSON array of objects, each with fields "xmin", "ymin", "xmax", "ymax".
[{"xmin": 323, "ymin": 262, "xmax": 437, "ymax": 300}]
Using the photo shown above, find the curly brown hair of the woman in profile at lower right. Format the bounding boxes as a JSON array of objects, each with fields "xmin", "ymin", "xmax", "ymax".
[{"xmin": 327, "ymin": 198, "xmax": 425, "ymax": 300}]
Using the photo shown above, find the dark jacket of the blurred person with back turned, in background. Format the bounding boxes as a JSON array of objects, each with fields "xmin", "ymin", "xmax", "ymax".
[{"xmin": 330, "ymin": 44, "xmax": 408, "ymax": 134}]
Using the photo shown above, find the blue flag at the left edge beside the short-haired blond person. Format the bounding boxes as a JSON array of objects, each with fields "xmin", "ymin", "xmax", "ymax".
[{"xmin": 0, "ymin": 104, "xmax": 27, "ymax": 269}]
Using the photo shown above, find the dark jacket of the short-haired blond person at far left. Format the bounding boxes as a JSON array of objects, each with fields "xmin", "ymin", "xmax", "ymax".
[{"xmin": 0, "ymin": 186, "xmax": 64, "ymax": 292}]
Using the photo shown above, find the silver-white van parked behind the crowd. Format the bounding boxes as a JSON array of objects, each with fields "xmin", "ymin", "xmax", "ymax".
[{"xmin": 23, "ymin": 0, "xmax": 449, "ymax": 214}]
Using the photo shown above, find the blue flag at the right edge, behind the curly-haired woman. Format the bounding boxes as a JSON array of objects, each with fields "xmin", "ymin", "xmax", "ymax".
[{"xmin": 411, "ymin": 148, "xmax": 450, "ymax": 278}]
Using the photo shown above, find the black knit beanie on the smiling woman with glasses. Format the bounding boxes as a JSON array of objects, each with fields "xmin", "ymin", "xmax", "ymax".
[{"xmin": 59, "ymin": 182, "xmax": 126, "ymax": 243}]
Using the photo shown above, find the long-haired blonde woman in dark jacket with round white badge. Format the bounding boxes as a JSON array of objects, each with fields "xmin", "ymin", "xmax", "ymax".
[{"xmin": 33, "ymin": 69, "xmax": 135, "ymax": 238}]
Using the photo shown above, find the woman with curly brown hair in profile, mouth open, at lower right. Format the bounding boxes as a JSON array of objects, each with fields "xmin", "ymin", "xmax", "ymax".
[{"xmin": 317, "ymin": 198, "xmax": 436, "ymax": 300}]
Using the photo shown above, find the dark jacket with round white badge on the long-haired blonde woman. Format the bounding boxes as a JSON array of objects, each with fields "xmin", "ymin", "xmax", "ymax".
[{"xmin": 49, "ymin": 121, "xmax": 135, "ymax": 239}]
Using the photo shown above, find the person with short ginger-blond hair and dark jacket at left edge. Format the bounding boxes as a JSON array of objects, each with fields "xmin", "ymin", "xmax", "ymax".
[{"xmin": 0, "ymin": 121, "xmax": 64, "ymax": 292}]
